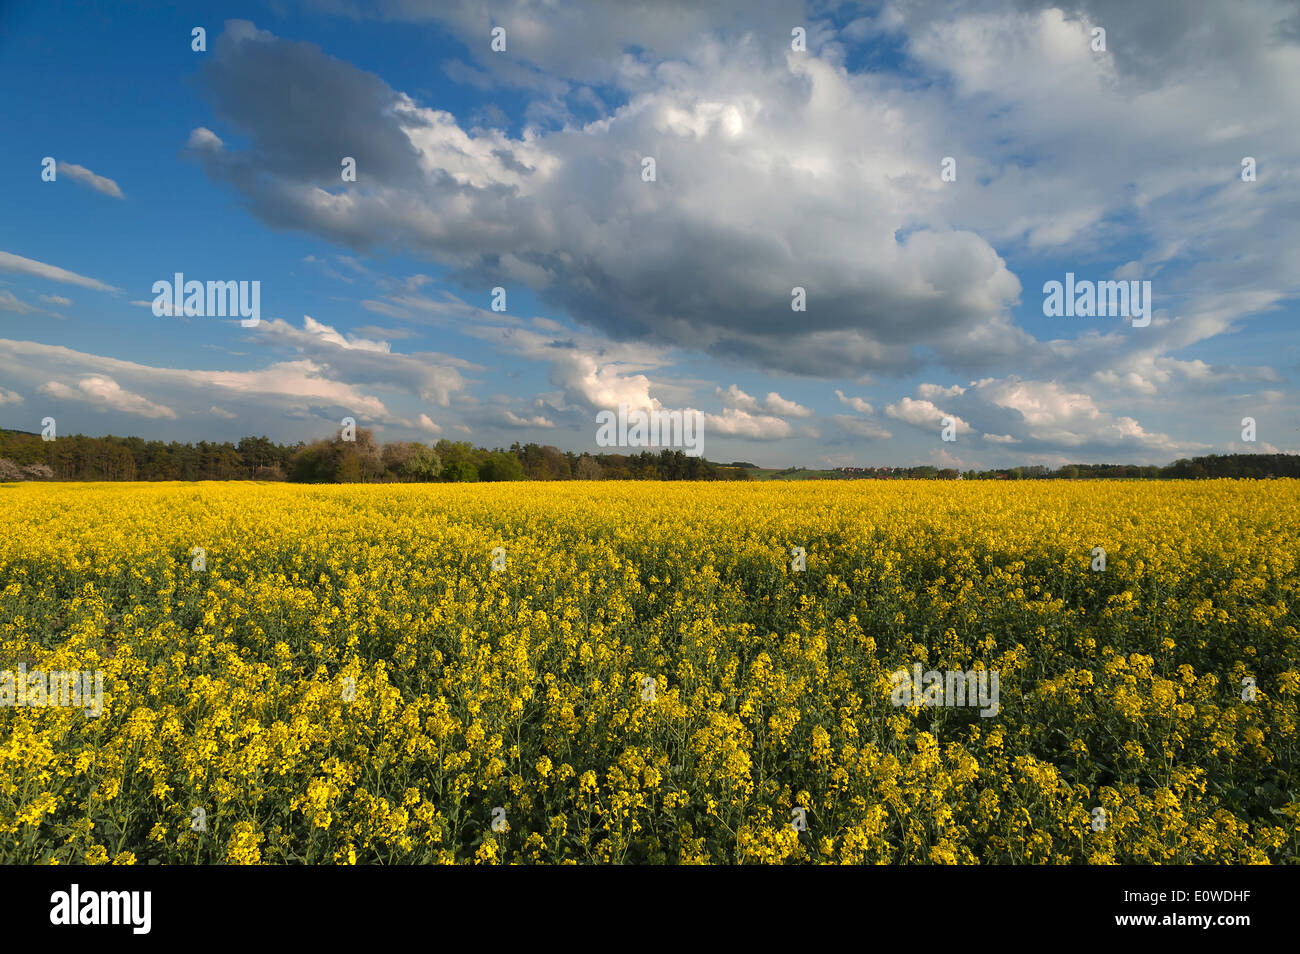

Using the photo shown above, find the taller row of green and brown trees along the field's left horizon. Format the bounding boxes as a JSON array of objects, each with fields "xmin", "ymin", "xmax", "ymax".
[{"xmin": 0, "ymin": 428, "xmax": 750, "ymax": 483}]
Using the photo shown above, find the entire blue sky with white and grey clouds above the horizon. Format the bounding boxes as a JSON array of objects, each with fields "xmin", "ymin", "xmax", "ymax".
[{"xmin": 0, "ymin": 0, "xmax": 1300, "ymax": 467}]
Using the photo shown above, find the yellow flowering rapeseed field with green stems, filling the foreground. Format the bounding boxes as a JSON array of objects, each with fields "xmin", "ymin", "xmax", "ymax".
[{"xmin": 0, "ymin": 481, "xmax": 1300, "ymax": 864}]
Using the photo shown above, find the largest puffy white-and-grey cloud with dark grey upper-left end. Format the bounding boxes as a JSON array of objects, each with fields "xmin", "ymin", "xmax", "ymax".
[{"xmin": 189, "ymin": 23, "xmax": 1021, "ymax": 374}]
